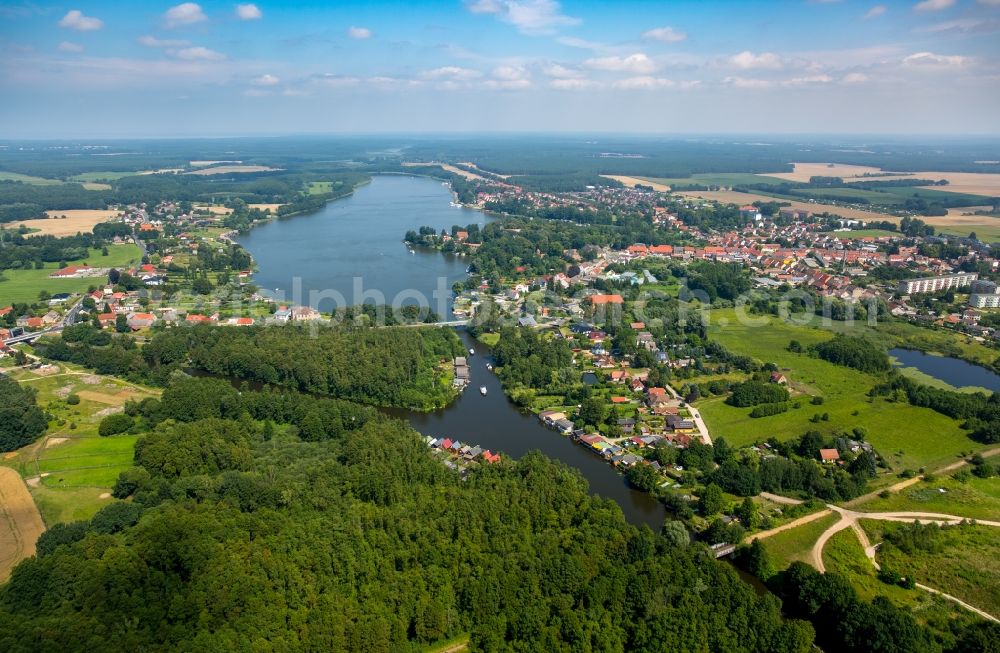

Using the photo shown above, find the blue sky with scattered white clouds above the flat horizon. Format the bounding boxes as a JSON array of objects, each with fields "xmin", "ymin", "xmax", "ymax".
[{"xmin": 0, "ymin": 0, "xmax": 1000, "ymax": 138}]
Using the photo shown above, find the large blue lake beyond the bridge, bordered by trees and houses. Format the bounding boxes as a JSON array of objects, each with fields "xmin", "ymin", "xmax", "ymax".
[{"xmin": 236, "ymin": 175, "xmax": 488, "ymax": 317}]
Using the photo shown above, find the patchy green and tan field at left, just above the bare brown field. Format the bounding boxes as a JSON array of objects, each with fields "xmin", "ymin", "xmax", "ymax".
[{"xmin": 2, "ymin": 364, "xmax": 156, "ymax": 526}]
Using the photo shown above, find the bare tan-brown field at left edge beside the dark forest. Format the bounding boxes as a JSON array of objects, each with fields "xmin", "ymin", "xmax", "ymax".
[{"xmin": 0, "ymin": 467, "xmax": 45, "ymax": 583}]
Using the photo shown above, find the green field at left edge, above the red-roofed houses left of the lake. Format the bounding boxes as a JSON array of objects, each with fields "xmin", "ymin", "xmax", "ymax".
[{"xmin": 0, "ymin": 244, "xmax": 142, "ymax": 307}]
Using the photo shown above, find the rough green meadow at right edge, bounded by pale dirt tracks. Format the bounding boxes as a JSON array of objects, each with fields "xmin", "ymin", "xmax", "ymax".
[{"xmin": 861, "ymin": 520, "xmax": 1000, "ymax": 615}]
